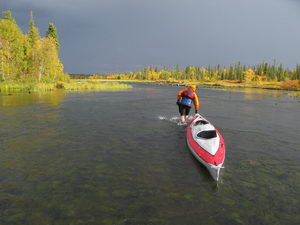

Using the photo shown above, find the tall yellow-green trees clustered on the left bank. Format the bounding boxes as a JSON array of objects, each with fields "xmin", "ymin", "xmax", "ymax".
[{"xmin": 0, "ymin": 11, "xmax": 69, "ymax": 82}]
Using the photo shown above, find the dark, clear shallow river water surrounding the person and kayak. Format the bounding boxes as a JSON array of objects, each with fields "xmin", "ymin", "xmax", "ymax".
[{"xmin": 0, "ymin": 84, "xmax": 300, "ymax": 225}]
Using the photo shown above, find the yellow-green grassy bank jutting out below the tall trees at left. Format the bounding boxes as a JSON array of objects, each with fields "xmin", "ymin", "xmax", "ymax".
[{"xmin": 0, "ymin": 79, "xmax": 132, "ymax": 93}]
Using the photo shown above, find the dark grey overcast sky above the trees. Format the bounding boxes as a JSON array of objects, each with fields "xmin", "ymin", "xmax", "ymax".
[{"xmin": 0, "ymin": 0, "xmax": 300, "ymax": 73}]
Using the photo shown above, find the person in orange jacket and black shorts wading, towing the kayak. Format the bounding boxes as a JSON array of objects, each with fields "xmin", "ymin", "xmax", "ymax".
[{"xmin": 176, "ymin": 85, "xmax": 199, "ymax": 123}]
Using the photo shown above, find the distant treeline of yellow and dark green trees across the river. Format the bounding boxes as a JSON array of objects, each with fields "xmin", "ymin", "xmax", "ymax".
[{"xmin": 90, "ymin": 62, "xmax": 300, "ymax": 82}]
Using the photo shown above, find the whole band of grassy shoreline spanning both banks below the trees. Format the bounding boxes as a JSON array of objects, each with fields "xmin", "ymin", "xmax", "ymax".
[{"xmin": 0, "ymin": 79, "xmax": 300, "ymax": 93}]
